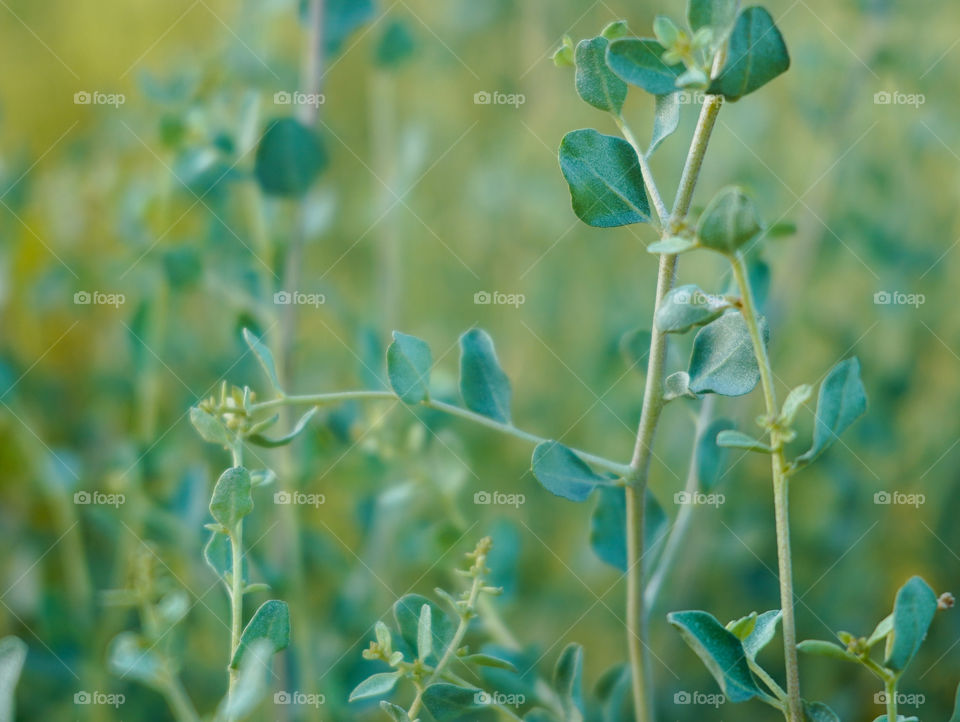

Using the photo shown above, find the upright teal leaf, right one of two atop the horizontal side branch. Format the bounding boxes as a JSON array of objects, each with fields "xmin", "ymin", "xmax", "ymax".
[{"xmin": 460, "ymin": 328, "xmax": 511, "ymax": 424}]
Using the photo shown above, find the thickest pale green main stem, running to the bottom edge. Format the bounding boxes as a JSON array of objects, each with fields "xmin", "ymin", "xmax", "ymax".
[{"xmin": 626, "ymin": 86, "xmax": 722, "ymax": 722}]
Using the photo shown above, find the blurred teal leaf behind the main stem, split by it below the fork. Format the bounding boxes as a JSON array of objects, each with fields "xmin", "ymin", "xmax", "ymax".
[{"xmin": 590, "ymin": 486, "xmax": 667, "ymax": 572}]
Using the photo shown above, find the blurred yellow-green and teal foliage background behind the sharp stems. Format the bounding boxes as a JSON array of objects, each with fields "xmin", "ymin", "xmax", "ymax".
[{"xmin": 0, "ymin": 0, "xmax": 960, "ymax": 721}]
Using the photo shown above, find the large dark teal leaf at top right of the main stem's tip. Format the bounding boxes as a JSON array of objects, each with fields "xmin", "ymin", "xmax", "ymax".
[{"xmin": 709, "ymin": 6, "xmax": 790, "ymax": 100}]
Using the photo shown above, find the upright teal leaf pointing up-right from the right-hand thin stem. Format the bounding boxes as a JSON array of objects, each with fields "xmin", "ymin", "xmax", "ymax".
[{"xmin": 797, "ymin": 356, "xmax": 867, "ymax": 464}]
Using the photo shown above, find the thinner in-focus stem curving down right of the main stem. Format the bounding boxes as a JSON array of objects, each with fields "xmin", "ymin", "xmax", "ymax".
[{"xmin": 731, "ymin": 253, "xmax": 803, "ymax": 722}]
